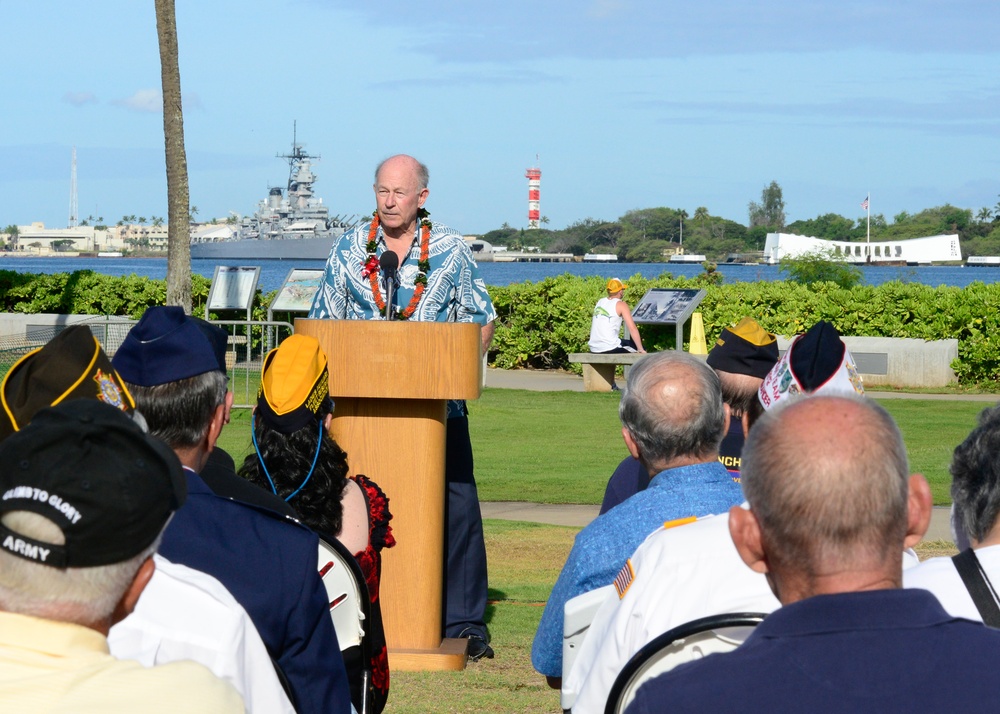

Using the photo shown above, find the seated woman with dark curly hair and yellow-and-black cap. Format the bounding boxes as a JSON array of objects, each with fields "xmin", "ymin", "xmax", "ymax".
[{"xmin": 240, "ymin": 335, "xmax": 396, "ymax": 712}]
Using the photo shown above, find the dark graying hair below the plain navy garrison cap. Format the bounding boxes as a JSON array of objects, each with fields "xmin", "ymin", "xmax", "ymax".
[{"xmin": 127, "ymin": 370, "xmax": 227, "ymax": 449}]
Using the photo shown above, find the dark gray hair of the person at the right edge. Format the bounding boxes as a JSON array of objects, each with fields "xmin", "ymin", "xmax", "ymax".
[{"xmin": 951, "ymin": 406, "xmax": 1000, "ymax": 541}]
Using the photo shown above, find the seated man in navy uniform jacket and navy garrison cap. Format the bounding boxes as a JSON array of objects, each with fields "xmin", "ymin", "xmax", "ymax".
[{"xmin": 112, "ymin": 307, "xmax": 351, "ymax": 714}]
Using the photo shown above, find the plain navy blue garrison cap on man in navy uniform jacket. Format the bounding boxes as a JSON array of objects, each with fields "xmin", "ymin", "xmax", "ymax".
[{"xmin": 111, "ymin": 307, "xmax": 225, "ymax": 387}]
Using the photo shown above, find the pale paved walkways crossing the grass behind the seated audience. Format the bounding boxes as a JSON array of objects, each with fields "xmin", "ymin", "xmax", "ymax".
[{"xmin": 481, "ymin": 369, "xmax": 980, "ymax": 541}]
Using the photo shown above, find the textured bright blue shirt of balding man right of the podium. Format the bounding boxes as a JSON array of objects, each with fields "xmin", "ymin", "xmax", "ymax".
[{"xmin": 531, "ymin": 461, "xmax": 743, "ymax": 677}]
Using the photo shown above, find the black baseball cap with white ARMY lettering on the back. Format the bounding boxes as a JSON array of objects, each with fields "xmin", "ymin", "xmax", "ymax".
[{"xmin": 0, "ymin": 399, "xmax": 187, "ymax": 568}]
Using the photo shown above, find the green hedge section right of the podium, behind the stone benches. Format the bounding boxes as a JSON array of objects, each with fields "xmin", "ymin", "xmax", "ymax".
[{"xmin": 490, "ymin": 275, "xmax": 1000, "ymax": 389}]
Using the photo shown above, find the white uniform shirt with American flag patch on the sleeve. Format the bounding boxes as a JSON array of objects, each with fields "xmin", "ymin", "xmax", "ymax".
[{"xmin": 564, "ymin": 503, "xmax": 924, "ymax": 714}]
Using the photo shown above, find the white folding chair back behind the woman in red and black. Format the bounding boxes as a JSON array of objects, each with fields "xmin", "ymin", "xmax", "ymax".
[{"xmin": 319, "ymin": 536, "xmax": 372, "ymax": 714}]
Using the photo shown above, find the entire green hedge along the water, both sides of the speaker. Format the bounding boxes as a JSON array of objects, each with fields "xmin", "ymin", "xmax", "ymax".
[{"xmin": 0, "ymin": 270, "xmax": 1000, "ymax": 388}]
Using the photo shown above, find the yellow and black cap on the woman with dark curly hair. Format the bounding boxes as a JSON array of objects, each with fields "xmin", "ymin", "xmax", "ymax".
[{"xmin": 257, "ymin": 335, "xmax": 332, "ymax": 434}]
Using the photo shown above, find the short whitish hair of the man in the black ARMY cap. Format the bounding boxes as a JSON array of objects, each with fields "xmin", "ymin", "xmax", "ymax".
[{"xmin": 0, "ymin": 511, "xmax": 162, "ymax": 625}]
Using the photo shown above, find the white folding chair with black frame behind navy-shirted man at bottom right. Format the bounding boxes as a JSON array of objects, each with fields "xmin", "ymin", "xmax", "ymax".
[{"xmin": 604, "ymin": 612, "xmax": 766, "ymax": 714}]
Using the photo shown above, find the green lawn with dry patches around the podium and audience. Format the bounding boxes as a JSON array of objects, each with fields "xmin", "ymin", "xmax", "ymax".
[{"xmin": 213, "ymin": 389, "xmax": 986, "ymax": 714}]
